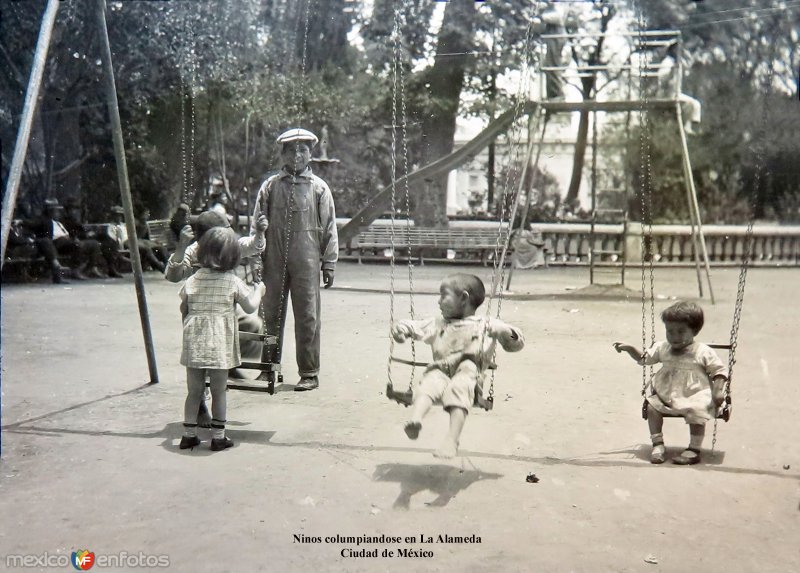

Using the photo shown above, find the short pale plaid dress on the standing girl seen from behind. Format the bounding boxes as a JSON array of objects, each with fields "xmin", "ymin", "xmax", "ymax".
[{"xmin": 180, "ymin": 268, "xmax": 251, "ymax": 370}]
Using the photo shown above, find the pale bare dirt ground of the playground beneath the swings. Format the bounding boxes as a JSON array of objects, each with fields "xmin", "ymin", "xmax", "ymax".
[{"xmin": 0, "ymin": 263, "xmax": 800, "ymax": 573}]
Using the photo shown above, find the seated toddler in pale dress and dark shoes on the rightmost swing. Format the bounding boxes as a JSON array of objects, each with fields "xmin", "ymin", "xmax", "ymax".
[{"xmin": 614, "ymin": 302, "xmax": 728, "ymax": 465}]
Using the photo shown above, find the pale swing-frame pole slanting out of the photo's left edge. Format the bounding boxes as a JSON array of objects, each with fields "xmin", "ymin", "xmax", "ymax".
[{"xmin": 0, "ymin": 0, "xmax": 59, "ymax": 268}]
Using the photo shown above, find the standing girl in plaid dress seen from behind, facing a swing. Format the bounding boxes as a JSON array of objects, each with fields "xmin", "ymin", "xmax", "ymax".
[{"xmin": 180, "ymin": 227, "xmax": 264, "ymax": 451}]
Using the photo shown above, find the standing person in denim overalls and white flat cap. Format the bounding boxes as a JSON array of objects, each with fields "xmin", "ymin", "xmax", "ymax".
[{"xmin": 253, "ymin": 129, "xmax": 339, "ymax": 392}]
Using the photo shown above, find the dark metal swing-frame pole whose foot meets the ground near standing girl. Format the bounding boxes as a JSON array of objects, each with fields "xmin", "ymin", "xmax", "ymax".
[{"xmin": 95, "ymin": 0, "xmax": 158, "ymax": 384}]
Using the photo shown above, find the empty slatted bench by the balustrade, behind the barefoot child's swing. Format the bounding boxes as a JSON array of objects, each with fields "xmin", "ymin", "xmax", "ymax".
[{"xmin": 348, "ymin": 223, "xmax": 507, "ymax": 265}]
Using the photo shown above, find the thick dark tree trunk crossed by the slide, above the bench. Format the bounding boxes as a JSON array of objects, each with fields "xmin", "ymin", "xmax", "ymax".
[{"xmin": 414, "ymin": 0, "xmax": 477, "ymax": 227}]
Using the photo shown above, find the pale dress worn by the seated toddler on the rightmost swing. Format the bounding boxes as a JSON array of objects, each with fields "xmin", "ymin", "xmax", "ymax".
[{"xmin": 645, "ymin": 341, "xmax": 728, "ymax": 424}]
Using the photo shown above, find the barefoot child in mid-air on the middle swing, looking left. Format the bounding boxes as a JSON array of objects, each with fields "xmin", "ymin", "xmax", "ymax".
[{"xmin": 392, "ymin": 274, "xmax": 525, "ymax": 459}]
